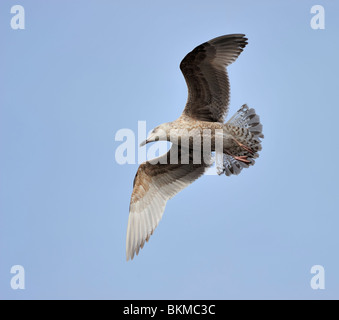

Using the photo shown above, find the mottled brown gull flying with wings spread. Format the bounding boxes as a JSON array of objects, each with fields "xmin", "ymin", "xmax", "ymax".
[{"xmin": 126, "ymin": 34, "xmax": 264, "ymax": 261}]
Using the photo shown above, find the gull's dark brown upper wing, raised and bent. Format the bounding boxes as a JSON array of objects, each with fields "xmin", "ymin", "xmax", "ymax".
[{"xmin": 180, "ymin": 34, "xmax": 247, "ymax": 122}]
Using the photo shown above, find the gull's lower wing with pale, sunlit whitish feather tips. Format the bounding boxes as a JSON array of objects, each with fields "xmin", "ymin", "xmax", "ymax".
[{"xmin": 126, "ymin": 145, "xmax": 211, "ymax": 260}]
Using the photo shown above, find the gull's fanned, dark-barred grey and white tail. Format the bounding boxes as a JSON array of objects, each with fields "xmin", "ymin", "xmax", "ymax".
[{"xmin": 218, "ymin": 104, "xmax": 264, "ymax": 176}]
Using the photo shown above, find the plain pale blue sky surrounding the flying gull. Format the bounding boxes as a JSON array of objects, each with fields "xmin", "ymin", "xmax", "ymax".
[{"xmin": 0, "ymin": 0, "xmax": 339, "ymax": 299}]
